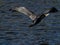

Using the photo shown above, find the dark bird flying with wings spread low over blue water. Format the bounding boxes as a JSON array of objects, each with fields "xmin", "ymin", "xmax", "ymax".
[{"xmin": 9, "ymin": 7, "xmax": 58, "ymax": 27}]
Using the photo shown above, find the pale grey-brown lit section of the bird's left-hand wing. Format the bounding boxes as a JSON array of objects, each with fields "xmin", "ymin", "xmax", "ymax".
[{"xmin": 14, "ymin": 7, "xmax": 36, "ymax": 20}]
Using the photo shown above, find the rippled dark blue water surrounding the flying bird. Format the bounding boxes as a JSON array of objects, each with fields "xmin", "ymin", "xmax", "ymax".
[{"xmin": 0, "ymin": 0, "xmax": 60, "ymax": 45}]
